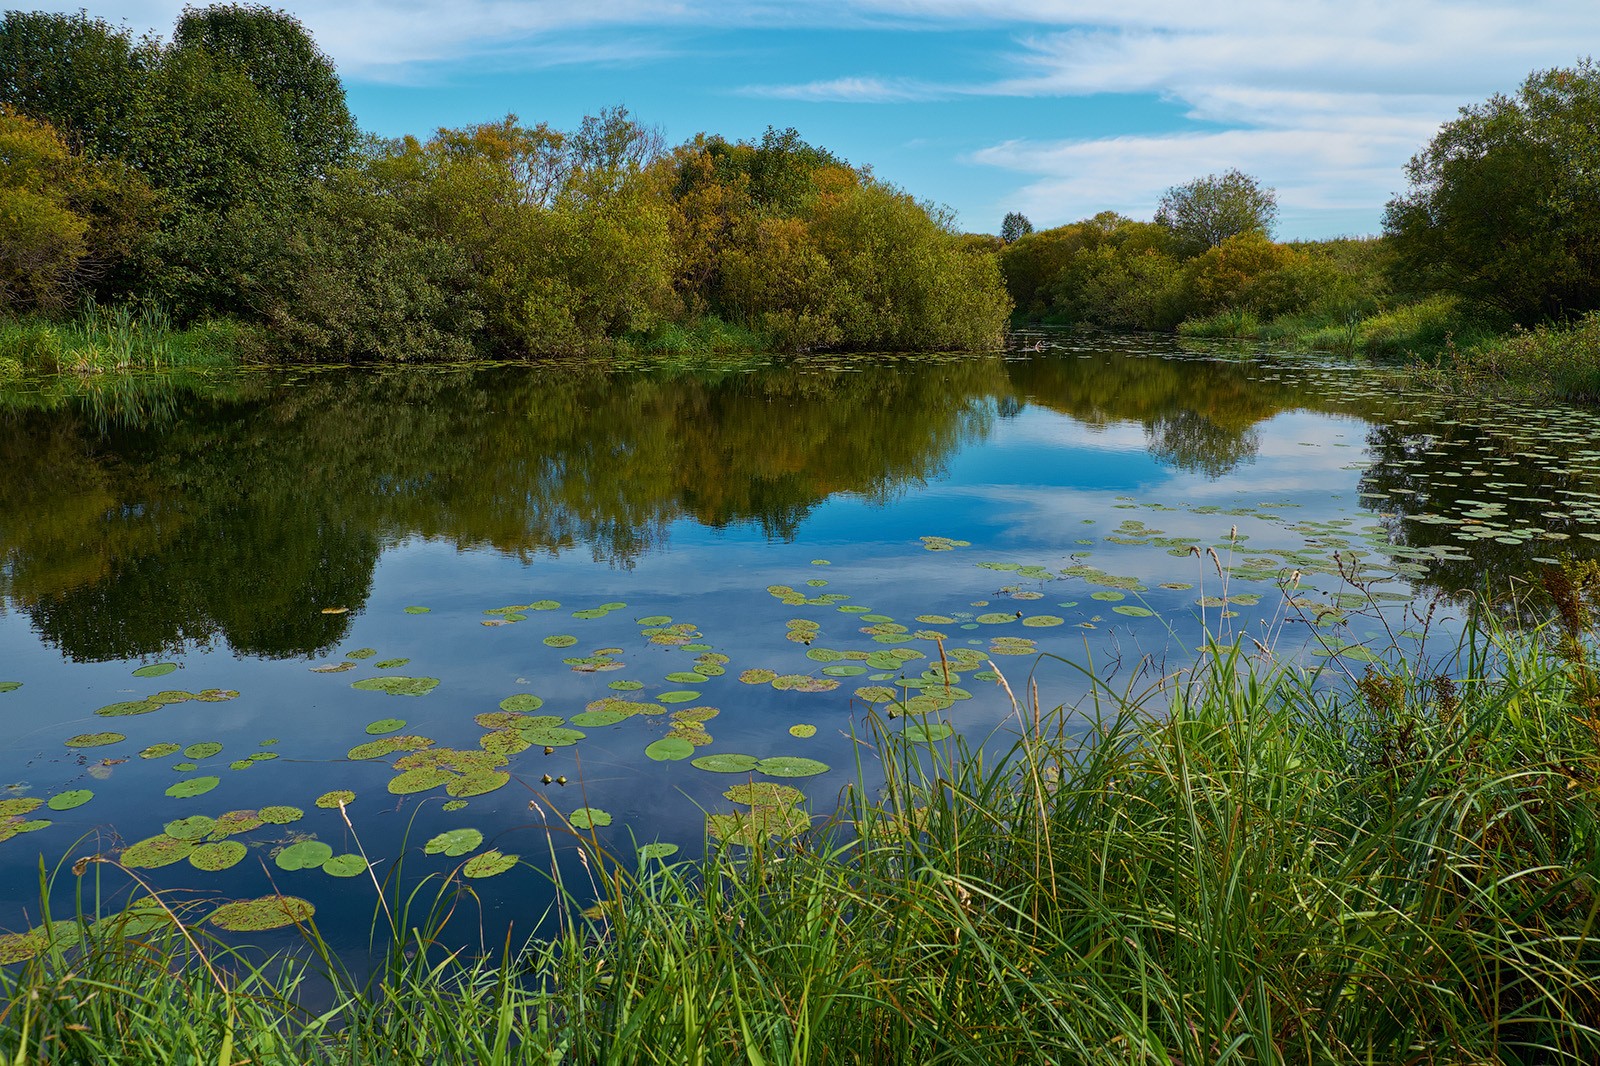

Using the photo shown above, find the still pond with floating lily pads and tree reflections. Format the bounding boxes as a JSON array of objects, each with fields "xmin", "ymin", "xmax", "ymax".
[{"xmin": 0, "ymin": 335, "xmax": 1600, "ymax": 952}]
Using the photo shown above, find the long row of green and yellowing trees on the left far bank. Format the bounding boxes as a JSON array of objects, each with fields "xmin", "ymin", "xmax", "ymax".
[{"xmin": 0, "ymin": 5, "xmax": 1011, "ymax": 359}]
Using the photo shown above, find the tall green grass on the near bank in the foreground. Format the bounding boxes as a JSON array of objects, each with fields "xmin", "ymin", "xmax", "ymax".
[{"xmin": 0, "ymin": 585, "xmax": 1600, "ymax": 1064}]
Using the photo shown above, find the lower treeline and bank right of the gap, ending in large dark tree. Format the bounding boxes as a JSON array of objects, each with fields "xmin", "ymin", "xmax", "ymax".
[{"xmin": 1000, "ymin": 59, "xmax": 1600, "ymax": 390}]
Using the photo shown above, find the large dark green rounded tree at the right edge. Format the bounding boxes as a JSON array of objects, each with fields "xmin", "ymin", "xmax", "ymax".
[{"xmin": 1384, "ymin": 59, "xmax": 1600, "ymax": 323}]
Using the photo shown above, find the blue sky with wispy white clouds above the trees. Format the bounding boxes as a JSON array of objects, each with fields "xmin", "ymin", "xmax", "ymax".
[{"xmin": 31, "ymin": 0, "xmax": 1600, "ymax": 238}]
